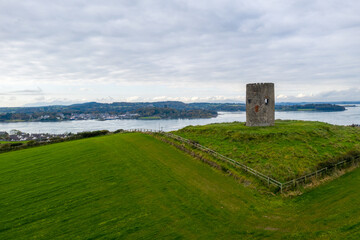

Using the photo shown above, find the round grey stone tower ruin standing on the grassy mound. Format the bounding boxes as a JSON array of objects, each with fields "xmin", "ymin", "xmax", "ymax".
[{"xmin": 246, "ymin": 83, "xmax": 275, "ymax": 126}]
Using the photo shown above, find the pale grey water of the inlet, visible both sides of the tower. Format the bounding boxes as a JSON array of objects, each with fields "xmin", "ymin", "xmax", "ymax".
[{"xmin": 0, "ymin": 105, "xmax": 360, "ymax": 134}]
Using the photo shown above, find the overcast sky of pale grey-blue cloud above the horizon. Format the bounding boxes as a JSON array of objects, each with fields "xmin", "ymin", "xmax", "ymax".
[{"xmin": 0, "ymin": 0, "xmax": 360, "ymax": 106}]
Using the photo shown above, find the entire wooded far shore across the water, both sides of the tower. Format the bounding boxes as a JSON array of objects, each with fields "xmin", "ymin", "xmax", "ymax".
[{"xmin": 0, "ymin": 101, "xmax": 345, "ymax": 122}]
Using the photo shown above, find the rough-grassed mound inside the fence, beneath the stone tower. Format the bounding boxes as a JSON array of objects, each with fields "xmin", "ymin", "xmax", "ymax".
[{"xmin": 174, "ymin": 120, "xmax": 360, "ymax": 181}]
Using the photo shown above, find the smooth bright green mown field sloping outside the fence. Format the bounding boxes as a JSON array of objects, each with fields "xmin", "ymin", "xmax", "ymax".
[{"xmin": 0, "ymin": 133, "xmax": 360, "ymax": 239}]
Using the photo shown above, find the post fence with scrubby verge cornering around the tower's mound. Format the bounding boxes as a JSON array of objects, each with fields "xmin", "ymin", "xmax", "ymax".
[{"xmin": 127, "ymin": 128, "xmax": 360, "ymax": 192}]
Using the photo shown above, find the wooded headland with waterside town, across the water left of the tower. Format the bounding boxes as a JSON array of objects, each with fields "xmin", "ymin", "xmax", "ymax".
[{"xmin": 0, "ymin": 101, "xmax": 217, "ymax": 121}]
